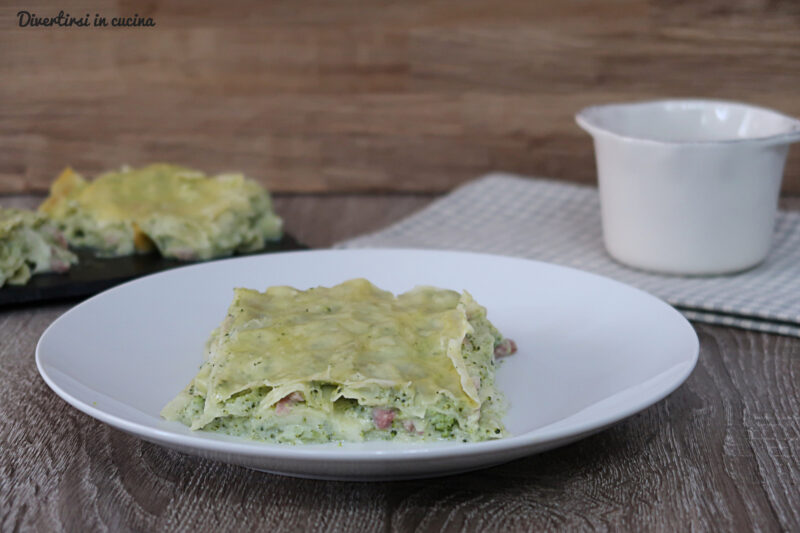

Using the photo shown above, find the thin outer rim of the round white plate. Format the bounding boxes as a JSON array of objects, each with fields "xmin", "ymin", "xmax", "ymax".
[{"xmin": 35, "ymin": 247, "xmax": 700, "ymax": 462}]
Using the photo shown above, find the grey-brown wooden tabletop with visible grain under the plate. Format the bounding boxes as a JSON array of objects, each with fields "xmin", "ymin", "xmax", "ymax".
[{"xmin": 0, "ymin": 195, "xmax": 800, "ymax": 532}]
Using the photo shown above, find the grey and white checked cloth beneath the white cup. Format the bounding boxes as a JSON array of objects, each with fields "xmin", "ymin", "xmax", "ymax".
[{"xmin": 338, "ymin": 174, "xmax": 800, "ymax": 337}]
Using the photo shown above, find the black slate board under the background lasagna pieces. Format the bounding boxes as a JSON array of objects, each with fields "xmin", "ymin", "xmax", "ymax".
[{"xmin": 0, "ymin": 234, "xmax": 308, "ymax": 308}]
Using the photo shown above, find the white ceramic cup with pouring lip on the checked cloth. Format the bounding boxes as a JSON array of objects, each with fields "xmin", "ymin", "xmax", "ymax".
[{"xmin": 575, "ymin": 100, "xmax": 800, "ymax": 275}]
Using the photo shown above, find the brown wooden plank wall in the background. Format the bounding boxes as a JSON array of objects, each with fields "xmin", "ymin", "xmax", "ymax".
[{"xmin": 0, "ymin": 0, "xmax": 800, "ymax": 193}]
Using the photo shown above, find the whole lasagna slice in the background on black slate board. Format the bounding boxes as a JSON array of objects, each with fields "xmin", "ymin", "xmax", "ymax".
[{"xmin": 39, "ymin": 164, "xmax": 282, "ymax": 261}]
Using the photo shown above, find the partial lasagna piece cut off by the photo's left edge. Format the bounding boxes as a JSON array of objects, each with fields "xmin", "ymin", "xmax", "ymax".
[{"xmin": 0, "ymin": 208, "xmax": 78, "ymax": 287}]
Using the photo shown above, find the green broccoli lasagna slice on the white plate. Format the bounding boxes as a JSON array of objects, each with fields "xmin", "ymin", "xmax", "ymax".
[{"xmin": 161, "ymin": 279, "xmax": 516, "ymax": 443}]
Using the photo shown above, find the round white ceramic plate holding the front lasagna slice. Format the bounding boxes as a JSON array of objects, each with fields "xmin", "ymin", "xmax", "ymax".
[{"xmin": 36, "ymin": 250, "xmax": 698, "ymax": 480}]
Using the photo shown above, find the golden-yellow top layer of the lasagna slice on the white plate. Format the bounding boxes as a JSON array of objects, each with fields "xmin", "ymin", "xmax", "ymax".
[{"xmin": 189, "ymin": 279, "xmax": 478, "ymax": 424}]
